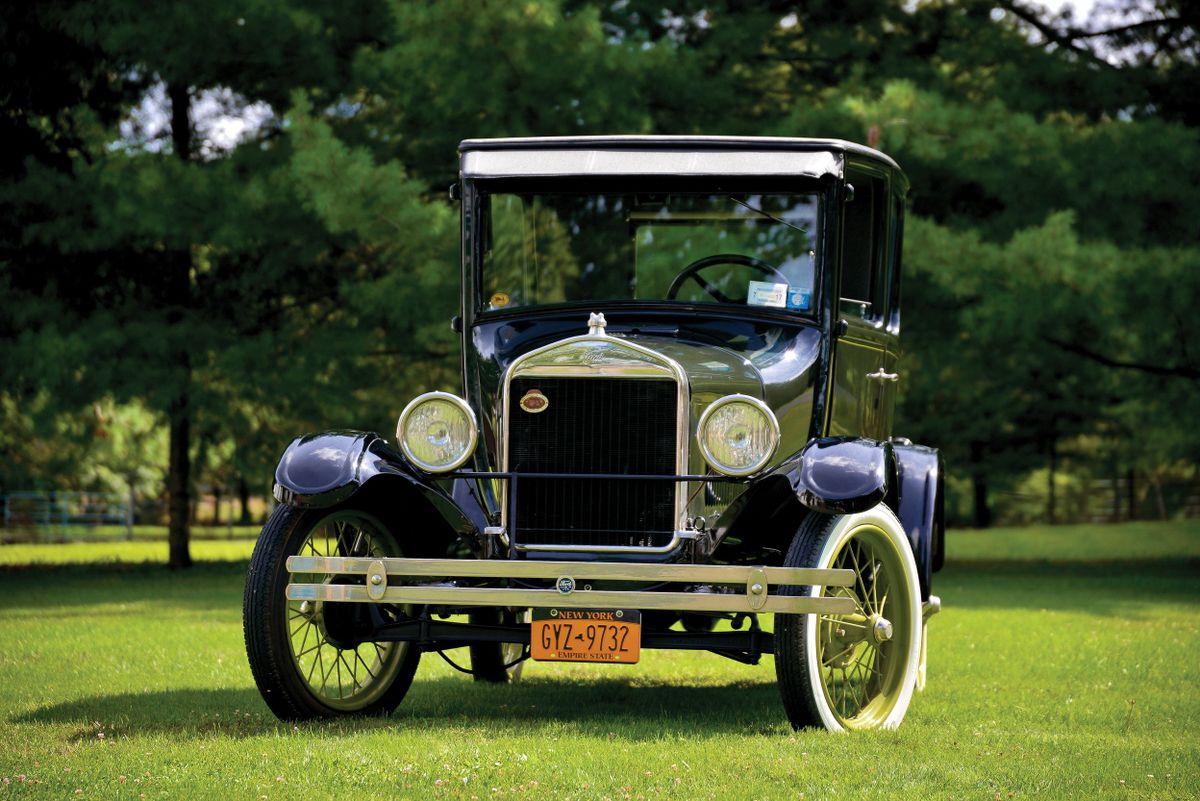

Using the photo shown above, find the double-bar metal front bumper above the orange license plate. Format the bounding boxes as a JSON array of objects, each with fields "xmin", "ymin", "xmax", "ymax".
[{"xmin": 287, "ymin": 556, "xmax": 854, "ymax": 614}]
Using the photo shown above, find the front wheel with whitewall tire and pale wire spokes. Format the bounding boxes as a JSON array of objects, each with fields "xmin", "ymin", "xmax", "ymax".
[{"xmin": 775, "ymin": 505, "xmax": 922, "ymax": 731}]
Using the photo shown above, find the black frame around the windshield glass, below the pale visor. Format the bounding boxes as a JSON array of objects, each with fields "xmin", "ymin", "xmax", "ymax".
[{"xmin": 462, "ymin": 175, "xmax": 833, "ymax": 324}]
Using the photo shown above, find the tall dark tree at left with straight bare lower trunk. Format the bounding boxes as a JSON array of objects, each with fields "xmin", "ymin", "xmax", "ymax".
[{"xmin": 4, "ymin": 2, "xmax": 432, "ymax": 567}]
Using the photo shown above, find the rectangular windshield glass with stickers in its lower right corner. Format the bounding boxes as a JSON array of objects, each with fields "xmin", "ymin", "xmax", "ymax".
[{"xmin": 480, "ymin": 192, "xmax": 820, "ymax": 313}]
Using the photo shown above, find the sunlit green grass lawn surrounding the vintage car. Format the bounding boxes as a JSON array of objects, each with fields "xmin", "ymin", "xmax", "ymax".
[{"xmin": 0, "ymin": 515, "xmax": 1200, "ymax": 801}]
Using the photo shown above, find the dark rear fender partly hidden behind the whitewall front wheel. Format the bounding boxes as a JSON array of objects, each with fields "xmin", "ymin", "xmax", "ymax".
[{"xmin": 893, "ymin": 444, "xmax": 946, "ymax": 600}]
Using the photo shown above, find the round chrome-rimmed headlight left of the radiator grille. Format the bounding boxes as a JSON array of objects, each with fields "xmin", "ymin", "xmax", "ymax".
[{"xmin": 396, "ymin": 392, "xmax": 479, "ymax": 472}]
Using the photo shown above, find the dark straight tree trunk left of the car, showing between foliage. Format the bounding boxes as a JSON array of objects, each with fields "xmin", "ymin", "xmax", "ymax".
[{"xmin": 164, "ymin": 83, "xmax": 192, "ymax": 568}]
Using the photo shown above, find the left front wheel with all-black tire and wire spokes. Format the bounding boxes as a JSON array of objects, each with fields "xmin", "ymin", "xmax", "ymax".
[{"xmin": 242, "ymin": 501, "xmax": 421, "ymax": 721}]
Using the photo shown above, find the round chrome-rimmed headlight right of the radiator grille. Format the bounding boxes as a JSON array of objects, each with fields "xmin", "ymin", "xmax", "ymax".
[{"xmin": 696, "ymin": 395, "xmax": 779, "ymax": 476}]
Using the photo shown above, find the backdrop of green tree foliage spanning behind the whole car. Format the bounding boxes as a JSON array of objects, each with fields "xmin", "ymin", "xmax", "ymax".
[{"xmin": 0, "ymin": 0, "xmax": 1200, "ymax": 551}]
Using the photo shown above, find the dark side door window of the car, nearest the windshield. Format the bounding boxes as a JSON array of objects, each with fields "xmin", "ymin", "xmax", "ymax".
[{"xmin": 841, "ymin": 171, "xmax": 888, "ymax": 320}]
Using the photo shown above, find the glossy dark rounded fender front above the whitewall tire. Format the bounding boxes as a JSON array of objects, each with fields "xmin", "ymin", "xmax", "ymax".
[{"xmin": 774, "ymin": 436, "xmax": 895, "ymax": 514}]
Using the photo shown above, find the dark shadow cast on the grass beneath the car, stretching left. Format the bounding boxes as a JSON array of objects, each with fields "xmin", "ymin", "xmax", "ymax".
[{"xmin": 8, "ymin": 668, "xmax": 787, "ymax": 742}]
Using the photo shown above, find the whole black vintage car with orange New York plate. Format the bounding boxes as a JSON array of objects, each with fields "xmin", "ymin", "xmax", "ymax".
[{"xmin": 245, "ymin": 137, "xmax": 943, "ymax": 730}]
